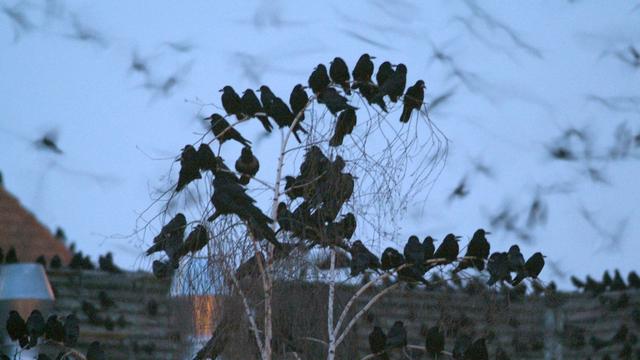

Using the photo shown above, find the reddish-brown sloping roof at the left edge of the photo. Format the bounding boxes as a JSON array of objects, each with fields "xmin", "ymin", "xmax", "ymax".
[{"xmin": 0, "ymin": 185, "xmax": 71, "ymax": 264}]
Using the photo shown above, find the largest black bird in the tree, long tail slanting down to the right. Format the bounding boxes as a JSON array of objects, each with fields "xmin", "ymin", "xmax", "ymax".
[{"xmin": 208, "ymin": 167, "xmax": 280, "ymax": 247}]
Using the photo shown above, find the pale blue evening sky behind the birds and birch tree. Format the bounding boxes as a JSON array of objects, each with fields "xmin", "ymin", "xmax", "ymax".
[{"xmin": 0, "ymin": 0, "xmax": 640, "ymax": 285}]
